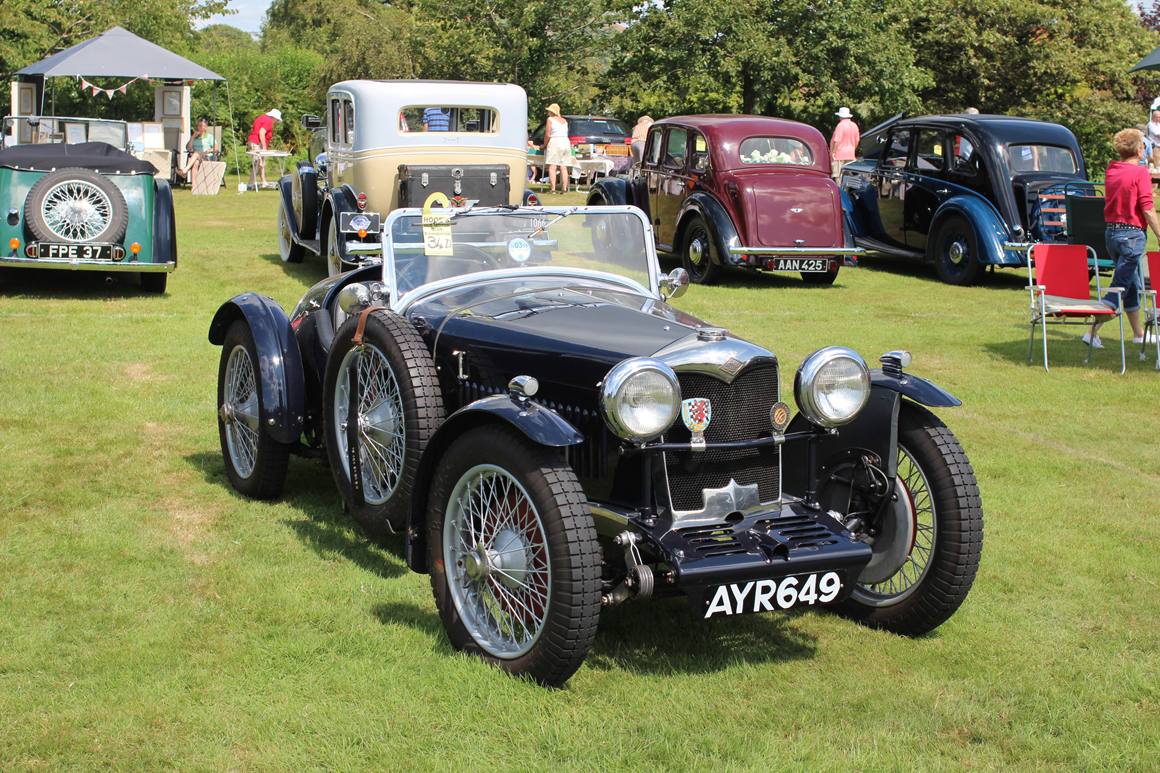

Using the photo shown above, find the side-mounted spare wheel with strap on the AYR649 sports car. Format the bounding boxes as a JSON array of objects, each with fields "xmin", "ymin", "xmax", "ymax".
[{"xmin": 319, "ymin": 309, "xmax": 443, "ymax": 534}]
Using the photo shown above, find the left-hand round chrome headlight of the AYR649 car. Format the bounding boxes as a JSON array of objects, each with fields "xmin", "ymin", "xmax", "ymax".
[{"xmin": 600, "ymin": 357, "xmax": 681, "ymax": 442}]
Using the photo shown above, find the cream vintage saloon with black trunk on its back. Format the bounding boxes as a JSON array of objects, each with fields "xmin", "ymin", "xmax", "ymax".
[{"xmin": 278, "ymin": 80, "xmax": 538, "ymax": 276}]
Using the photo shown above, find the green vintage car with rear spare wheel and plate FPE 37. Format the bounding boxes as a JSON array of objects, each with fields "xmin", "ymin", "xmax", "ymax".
[{"xmin": 0, "ymin": 143, "xmax": 177, "ymax": 292}]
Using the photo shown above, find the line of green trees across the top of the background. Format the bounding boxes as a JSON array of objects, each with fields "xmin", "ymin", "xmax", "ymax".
[{"xmin": 0, "ymin": 0, "xmax": 1160, "ymax": 172}]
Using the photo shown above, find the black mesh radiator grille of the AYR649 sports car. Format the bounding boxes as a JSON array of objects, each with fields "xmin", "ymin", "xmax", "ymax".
[{"xmin": 665, "ymin": 364, "xmax": 781, "ymax": 511}]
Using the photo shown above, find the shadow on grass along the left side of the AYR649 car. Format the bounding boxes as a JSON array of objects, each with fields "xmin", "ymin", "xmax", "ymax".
[{"xmin": 184, "ymin": 451, "xmax": 408, "ymax": 578}]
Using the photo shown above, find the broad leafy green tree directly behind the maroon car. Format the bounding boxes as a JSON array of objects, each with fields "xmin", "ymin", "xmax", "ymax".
[{"xmin": 607, "ymin": 0, "xmax": 930, "ymax": 125}]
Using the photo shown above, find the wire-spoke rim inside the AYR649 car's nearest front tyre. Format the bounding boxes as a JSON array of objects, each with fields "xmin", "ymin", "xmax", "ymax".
[{"xmin": 443, "ymin": 464, "xmax": 552, "ymax": 658}]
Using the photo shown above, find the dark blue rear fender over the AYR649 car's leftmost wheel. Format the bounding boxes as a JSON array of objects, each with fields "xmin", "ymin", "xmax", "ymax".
[{"xmin": 209, "ymin": 292, "xmax": 306, "ymax": 443}]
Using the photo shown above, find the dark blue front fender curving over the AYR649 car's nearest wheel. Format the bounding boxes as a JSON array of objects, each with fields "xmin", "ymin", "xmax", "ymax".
[{"xmin": 404, "ymin": 395, "xmax": 583, "ymax": 573}]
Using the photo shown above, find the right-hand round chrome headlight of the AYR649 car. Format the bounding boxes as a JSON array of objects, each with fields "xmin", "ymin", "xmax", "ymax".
[{"xmin": 793, "ymin": 346, "xmax": 870, "ymax": 427}]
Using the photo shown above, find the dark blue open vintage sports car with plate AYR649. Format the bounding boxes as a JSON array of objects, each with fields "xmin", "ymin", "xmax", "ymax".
[{"xmin": 209, "ymin": 207, "xmax": 983, "ymax": 685}]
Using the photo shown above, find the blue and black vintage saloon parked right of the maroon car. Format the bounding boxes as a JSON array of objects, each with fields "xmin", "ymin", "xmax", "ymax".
[{"xmin": 841, "ymin": 115, "xmax": 1102, "ymax": 284}]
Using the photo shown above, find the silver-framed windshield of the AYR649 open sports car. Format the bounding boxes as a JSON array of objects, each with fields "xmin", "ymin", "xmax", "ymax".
[{"xmin": 387, "ymin": 208, "xmax": 654, "ymax": 296}]
